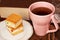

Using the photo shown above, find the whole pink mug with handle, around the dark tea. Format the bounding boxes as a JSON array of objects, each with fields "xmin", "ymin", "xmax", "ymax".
[{"xmin": 29, "ymin": 1, "xmax": 58, "ymax": 36}]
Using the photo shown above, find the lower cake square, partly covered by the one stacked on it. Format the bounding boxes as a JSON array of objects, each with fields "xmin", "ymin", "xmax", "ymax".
[{"xmin": 7, "ymin": 24, "xmax": 23, "ymax": 35}]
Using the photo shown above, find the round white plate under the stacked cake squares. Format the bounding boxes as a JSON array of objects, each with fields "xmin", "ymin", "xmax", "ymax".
[{"xmin": 0, "ymin": 20, "xmax": 33, "ymax": 40}]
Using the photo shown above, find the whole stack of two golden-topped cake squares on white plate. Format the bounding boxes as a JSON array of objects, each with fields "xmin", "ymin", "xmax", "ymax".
[{"xmin": 5, "ymin": 14, "xmax": 23, "ymax": 35}]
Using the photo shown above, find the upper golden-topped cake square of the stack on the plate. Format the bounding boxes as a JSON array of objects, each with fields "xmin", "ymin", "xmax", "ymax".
[{"xmin": 6, "ymin": 14, "xmax": 22, "ymax": 28}]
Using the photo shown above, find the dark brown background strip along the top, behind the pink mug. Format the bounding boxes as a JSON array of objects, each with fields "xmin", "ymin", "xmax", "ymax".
[{"xmin": 0, "ymin": 0, "xmax": 60, "ymax": 8}]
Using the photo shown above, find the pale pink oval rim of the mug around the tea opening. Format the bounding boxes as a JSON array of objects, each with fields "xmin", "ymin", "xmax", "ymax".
[{"xmin": 29, "ymin": 1, "xmax": 55, "ymax": 17}]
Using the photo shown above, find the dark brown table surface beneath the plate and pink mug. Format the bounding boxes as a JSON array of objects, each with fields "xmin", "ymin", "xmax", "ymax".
[{"xmin": 0, "ymin": 17, "xmax": 57, "ymax": 40}]
